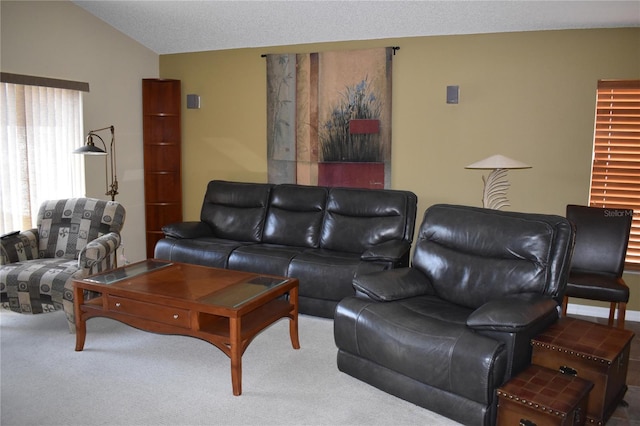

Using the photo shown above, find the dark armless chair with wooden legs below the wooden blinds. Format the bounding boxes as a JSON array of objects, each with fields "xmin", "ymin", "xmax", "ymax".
[{"xmin": 562, "ymin": 204, "xmax": 633, "ymax": 328}]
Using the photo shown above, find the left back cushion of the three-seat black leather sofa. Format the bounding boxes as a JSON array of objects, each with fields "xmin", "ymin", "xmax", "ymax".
[{"xmin": 200, "ymin": 180, "xmax": 273, "ymax": 242}]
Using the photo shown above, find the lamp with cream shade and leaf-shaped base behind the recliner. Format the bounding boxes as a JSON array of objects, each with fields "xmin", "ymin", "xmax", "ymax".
[{"xmin": 465, "ymin": 154, "xmax": 531, "ymax": 210}]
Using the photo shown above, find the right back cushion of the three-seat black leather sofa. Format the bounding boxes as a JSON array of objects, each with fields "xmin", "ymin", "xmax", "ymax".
[{"xmin": 320, "ymin": 188, "xmax": 413, "ymax": 253}]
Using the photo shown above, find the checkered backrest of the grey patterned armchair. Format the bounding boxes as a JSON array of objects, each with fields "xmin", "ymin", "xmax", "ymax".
[{"xmin": 37, "ymin": 198, "xmax": 125, "ymax": 259}]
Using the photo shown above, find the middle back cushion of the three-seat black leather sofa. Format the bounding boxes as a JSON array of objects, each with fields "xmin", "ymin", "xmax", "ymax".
[{"xmin": 262, "ymin": 185, "xmax": 328, "ymax": 247}]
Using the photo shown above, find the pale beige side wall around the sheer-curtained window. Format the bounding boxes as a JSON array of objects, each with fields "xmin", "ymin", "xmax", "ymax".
[{"xmin": 0, "ymin": 0, "xmax": 158, "ymax": 261}]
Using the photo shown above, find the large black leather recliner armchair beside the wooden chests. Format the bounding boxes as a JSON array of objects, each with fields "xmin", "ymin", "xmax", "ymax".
[{"xmin": 334, "ymin": 205, "xmax": 574, "ymax": 425}]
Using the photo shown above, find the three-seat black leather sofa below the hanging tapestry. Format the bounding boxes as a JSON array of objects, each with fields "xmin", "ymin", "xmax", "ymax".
[{"xmin": 154, "ymin": 180, "xmax": 417, "ymax": 318}]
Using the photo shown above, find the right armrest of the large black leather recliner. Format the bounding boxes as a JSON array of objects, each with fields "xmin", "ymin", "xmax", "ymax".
[{"xmin": 467, "ymin": 293, "xmax": 558, "ymax": 333}]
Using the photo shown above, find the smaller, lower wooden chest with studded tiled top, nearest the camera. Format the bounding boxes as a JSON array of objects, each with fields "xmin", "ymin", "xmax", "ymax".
[{"xmin": 497, "ymin": 365, "xmax": 593, "ymax": 426}]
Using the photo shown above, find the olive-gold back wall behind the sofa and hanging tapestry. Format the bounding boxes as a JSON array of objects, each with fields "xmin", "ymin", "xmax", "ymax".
[{"xmin": 160, "ymin": 28, "xmax": 640, "ymax": 312}]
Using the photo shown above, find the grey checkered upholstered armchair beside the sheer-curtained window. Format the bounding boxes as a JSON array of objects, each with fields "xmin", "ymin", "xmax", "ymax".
[{"xmin": 0, "ymin": 198, "xmax": 125, "ymax": 332}]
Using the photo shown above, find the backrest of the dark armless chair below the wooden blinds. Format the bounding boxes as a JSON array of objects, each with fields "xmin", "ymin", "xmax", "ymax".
[{"xmin": 567, "ymin": 204, "xmax": 633, "ymax": 277}]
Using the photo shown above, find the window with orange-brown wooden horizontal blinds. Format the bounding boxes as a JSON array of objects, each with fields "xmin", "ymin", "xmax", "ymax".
[{"xmin": 589, "ymin": 80, "xmax": 640, "ymax": 271}]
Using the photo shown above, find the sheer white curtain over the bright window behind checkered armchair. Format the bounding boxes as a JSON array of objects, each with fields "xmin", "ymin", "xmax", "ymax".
[{"xmin": 0, "ymin": 83, "xmax": 85, "ymax": 234}]
